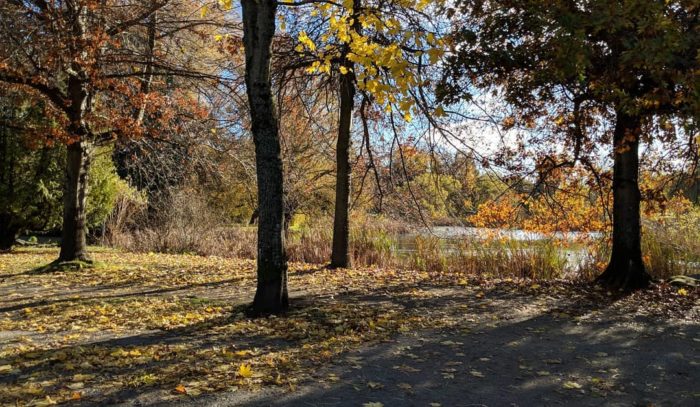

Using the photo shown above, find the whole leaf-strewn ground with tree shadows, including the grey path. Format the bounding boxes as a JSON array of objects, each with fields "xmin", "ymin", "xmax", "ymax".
[{"xmin": 0, "ymin": 248, "xmax": 700, "ymax": 406}]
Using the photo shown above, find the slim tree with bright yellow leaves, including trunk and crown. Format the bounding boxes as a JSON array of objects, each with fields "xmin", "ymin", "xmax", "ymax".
[{"xmin": 296, "ymin": 0, "xmax": 443, "ymax": 267}]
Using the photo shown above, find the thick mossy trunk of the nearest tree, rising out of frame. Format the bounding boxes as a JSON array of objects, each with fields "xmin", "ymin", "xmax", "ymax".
[{"xmin": 241, "ymin": 0, "xmax": 289, "ymax": 315}]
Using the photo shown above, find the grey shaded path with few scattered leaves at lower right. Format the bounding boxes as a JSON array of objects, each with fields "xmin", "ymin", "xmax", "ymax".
[{"xmin": 149, "ymin": 298, "xmax": 700, "ymax": 407}]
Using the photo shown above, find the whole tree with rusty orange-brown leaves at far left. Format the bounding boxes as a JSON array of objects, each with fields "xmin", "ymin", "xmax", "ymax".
[{"xmin": 0, "ymin": 0, "xmax": 174, "ymax": 261}]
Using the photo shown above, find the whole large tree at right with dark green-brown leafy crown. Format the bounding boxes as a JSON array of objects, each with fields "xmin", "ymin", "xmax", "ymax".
[{"xmin": 441, "ymin": 0, "xmax": 700, "ymax": 289}]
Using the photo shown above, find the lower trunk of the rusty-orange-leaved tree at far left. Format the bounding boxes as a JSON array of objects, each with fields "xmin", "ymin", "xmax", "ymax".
[{"xmin": 58, "ymin": 141, "xmax": 91, "ymax": 261}]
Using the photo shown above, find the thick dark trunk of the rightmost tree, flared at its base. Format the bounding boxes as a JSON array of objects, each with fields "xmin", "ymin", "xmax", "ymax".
[{"xmin": 598, "ymin": 112, "xmax": 651, "ymax": 290}]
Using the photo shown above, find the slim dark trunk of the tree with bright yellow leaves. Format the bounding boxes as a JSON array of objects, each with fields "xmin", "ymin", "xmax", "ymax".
[{"xmin": 330, "ymin": 0, "xmax": 362, "ymax": 268}]
